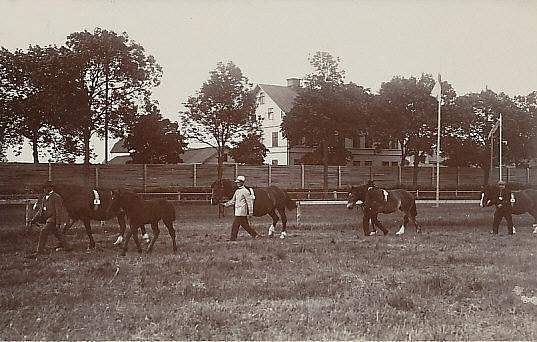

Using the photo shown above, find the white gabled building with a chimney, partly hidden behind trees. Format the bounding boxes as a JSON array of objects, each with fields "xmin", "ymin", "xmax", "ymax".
[{"xmin": 254, "ymin": 78, "xmax": 401, "ymax": 166}]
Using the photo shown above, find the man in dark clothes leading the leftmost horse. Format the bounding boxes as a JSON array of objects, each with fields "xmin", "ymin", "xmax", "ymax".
[{"xmin": 36, "ymin": 181, "xmax": 71, "ymax": 254}]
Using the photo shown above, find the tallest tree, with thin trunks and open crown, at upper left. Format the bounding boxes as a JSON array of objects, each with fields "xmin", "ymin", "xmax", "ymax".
[{"xmin": 66, "ymin": 28, "xmax": 162, "ymax": 164}]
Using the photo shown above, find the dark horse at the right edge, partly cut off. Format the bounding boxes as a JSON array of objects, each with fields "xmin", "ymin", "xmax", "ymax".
[{"xmin": 480, "ymin": 184, "xmax": 537, "ymax": 234}]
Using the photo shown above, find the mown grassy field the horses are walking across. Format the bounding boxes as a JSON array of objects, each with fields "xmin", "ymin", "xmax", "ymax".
[{"xmin": 0, "ymin": 205, "xmax": 537, "ymax": 340}]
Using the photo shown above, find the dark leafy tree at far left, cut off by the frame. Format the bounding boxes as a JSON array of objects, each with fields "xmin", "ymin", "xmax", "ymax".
[{"xmin": 0, "ymin": 46, "xmax": 80, "ymax": 163}]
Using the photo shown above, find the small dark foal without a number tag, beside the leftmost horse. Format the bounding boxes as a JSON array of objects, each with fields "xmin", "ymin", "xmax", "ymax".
[{"xmin": 110, "ymin": 189, "xmax": 177, "ymax": 255}]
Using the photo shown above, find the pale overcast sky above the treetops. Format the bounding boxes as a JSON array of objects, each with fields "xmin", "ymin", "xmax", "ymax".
[{"xmin": 0, "ymin": 0, "xmax": 537, "ymax": 162}]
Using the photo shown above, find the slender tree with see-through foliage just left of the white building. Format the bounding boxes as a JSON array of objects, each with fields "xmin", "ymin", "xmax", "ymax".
[{"xmin": 182, "ymin": 62, "xmax": 257, "ymax": 180}]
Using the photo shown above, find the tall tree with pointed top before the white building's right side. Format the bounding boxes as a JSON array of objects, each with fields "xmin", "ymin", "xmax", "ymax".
[{"xmin": 282, "ymin": 51, "xmax": 371, "ymax": 192}]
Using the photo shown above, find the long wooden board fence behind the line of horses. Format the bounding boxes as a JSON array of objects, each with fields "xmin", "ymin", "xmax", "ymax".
[{"xmin": 0, "ymin": 163, "xmax": 537, "ymax": 195}]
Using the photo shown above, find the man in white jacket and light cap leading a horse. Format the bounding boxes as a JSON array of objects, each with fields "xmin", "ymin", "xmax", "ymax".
[{"xmin": 219, "ymin": 176, "xmax": 260, "ymax": 241}]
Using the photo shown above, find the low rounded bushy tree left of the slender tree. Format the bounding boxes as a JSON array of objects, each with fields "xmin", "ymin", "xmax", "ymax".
[{"xmin": 124, "ymin": 111, "xmax": 186, "ymax": 164}]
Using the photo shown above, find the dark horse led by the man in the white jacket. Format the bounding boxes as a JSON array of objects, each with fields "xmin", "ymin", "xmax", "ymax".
[{"xmin": 211, "ymin": 179, "xmax": 296, "ymax": 239}]
